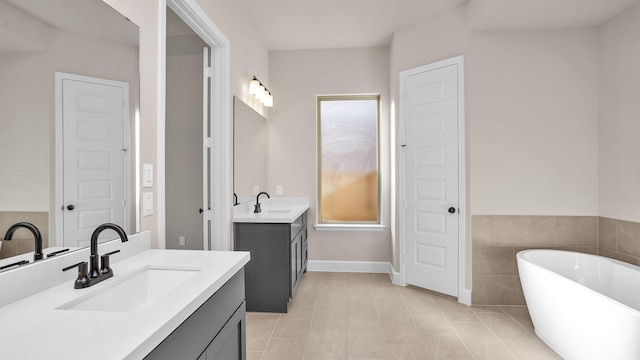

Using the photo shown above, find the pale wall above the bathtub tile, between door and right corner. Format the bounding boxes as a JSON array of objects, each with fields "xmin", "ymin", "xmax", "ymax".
[{"xmin": 467, "ymin": 28, "xmax": 598, "ymax": 215}]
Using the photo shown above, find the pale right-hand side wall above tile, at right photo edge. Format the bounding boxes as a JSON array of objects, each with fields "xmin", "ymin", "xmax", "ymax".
[{"xmin": 599, "ymin": 5, "xmax": 640, "ymax": 222}]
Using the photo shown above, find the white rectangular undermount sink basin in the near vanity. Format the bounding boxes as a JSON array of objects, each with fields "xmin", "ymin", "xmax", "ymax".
[{"xmin": 56, "ymin": 266, "xmax": 200, "ymax": 312}]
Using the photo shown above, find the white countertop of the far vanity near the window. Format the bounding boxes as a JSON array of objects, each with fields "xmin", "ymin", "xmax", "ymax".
[{"xmin": 233, "ymin": 197, "xmax": 309, "ymax": 223}]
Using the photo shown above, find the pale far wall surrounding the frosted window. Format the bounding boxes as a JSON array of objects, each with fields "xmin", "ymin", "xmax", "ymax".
[{"xmin": 269, "ymin": 48, "xmax": 391, "ymax": 262}]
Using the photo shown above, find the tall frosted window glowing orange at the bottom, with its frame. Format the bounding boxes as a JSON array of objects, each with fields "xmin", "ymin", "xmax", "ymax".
[{"xmin": 317, "ymin": 95, "xmax": 380, "ymax": 225}]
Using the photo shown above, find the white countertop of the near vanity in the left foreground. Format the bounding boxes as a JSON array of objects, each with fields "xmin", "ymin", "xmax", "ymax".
[{"xmin": 0, "ymin": 250, "xmax": 249, "ymax": 360}]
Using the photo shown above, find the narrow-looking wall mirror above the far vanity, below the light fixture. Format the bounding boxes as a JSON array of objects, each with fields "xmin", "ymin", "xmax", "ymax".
[{"xmin": 233, "ymin": 97, "xmax": 269, "ymax": 203}]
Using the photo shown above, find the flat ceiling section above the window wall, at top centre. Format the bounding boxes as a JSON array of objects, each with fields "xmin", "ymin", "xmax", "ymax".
[{"xmin": 240, "ymin": 0, "xmax": 468, "ymax": 50}]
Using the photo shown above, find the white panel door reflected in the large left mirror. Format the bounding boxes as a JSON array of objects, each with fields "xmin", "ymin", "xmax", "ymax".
[{"xmin": 61, "ymin": 77, "xmax": 129, "ymax": 247}]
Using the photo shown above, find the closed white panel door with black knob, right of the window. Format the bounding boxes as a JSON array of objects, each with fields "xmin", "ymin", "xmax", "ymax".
[{"xmin": 401, "ymin": 64, "xmax": 459, "ymax": 296}]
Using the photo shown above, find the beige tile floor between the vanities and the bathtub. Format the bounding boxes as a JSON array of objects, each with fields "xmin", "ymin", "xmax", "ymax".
[{"xmin": 247, "ymin": 272, "xmax": 561, "ymax": 360}]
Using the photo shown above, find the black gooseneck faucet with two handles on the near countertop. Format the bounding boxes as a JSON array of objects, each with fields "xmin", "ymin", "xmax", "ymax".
[{"xmin": 62, "ymin": 223, "xmax": 129, "ymax": 289}]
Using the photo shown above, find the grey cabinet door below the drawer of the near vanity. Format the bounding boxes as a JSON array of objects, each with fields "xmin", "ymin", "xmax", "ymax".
[{"xmin": 204, "ymin": 303, "xmax": 247, "ymax": 360}]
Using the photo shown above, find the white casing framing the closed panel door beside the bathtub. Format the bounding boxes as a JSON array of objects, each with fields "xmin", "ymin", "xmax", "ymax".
[{"xmin": 398, "ymin": 55, "xmax": 471, "ymax": 305}]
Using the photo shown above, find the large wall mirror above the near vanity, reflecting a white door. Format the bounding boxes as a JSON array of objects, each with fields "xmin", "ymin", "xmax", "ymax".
[{"xmin": 0, "ymin": 0, "xmax": 140, "ymax": 267}]
